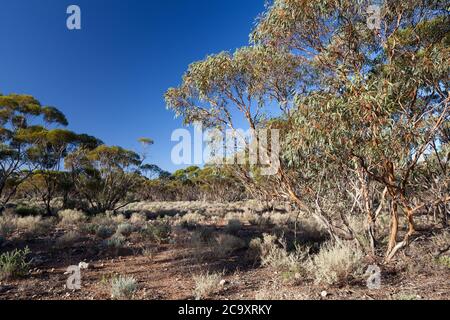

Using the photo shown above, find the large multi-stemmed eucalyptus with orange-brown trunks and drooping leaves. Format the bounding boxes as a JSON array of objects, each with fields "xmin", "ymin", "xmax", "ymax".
[{"xmin": 166, "ymin": 0, "xmax": 450, "ymax": 260}]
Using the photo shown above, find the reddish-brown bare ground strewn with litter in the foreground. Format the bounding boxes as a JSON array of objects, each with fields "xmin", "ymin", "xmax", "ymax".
[{"xmin": 0, "ymin": 202, "xmax": 450, "ymax": 300}]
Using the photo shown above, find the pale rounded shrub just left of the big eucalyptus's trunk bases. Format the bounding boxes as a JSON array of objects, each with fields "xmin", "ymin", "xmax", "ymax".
[{"xmin": 308, "ymin": 243, "xmax": 363, "ymax": 285}]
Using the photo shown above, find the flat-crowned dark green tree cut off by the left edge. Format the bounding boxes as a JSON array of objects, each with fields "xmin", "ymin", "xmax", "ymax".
[{"xmin": 0, "ymin": 94, "xmax": 67, "ymax": 206}]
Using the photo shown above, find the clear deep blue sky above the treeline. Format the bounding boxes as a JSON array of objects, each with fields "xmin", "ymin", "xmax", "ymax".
[{"xmin": 0, "ymin": 0, "xmax": 264, "ymax": 171}]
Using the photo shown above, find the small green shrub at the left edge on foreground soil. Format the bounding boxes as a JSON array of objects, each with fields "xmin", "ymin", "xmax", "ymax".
[{"xmin": 0, "ymin": 247, "xmax": 31, "ymax": 280}]
